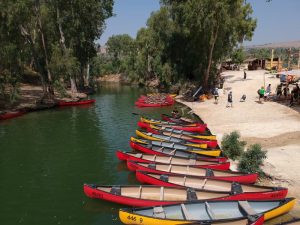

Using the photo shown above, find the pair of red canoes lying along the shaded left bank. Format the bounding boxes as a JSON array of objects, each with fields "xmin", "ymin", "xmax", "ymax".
[{"xmin": 0, "ymin": 99, "xmax": 96, "ymax": 120}]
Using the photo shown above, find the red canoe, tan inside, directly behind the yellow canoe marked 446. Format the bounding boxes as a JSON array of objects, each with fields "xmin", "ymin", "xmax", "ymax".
[{"xmin": 83, "ymin": 184, "xmax": 284, "ymax": 207}]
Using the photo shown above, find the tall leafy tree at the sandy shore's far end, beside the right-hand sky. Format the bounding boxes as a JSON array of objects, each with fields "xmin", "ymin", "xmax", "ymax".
[{"xmin": 162, "ymin": 0, "xmax": 256, "ymax": 87}]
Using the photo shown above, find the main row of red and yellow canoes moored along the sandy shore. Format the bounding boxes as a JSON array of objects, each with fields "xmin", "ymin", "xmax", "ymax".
[{"xmin": 84, "ymin": 115, "xmax": 295, "ymax": 225}]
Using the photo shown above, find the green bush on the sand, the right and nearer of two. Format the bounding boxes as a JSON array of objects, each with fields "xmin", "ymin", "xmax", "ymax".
[{"xmin": 238, "ymin": 144, "xmax": 267, "ymax": 175}]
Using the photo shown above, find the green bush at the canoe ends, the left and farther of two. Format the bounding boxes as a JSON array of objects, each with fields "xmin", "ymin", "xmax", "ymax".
[{"xmin": 221, "ymin": 131, "xmax": 246, "ymax": 160}]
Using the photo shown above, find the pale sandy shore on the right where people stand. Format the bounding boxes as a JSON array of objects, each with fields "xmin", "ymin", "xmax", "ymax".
[{"xmin": 179, "ymin": 70, "xmax": 300, "ymax": 207}]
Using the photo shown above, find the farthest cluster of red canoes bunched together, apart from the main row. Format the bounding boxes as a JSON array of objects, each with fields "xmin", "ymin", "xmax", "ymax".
[{"xmin": 135, "ymin": 94, "xmax": 174, "ymax": 107}]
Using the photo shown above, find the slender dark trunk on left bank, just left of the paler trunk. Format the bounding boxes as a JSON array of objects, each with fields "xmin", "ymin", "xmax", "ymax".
[{"xmin": 35, "ymin": 0, "xmax": 54, "ymax": 96}]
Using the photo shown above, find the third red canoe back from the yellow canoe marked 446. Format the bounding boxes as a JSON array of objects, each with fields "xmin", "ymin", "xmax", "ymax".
[{"xmin": 127, "ymin": 160, "xmax": 258, "ymax": 184}]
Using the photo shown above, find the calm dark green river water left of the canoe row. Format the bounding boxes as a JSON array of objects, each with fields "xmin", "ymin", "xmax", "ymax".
[{"xmin": 0, "ymin": 85, "xmax": 298, "ymax": 225}]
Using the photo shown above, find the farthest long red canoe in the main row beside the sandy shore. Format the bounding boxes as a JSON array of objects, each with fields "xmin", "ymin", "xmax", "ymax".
[{"xmin": 137, "ymin": 121, "xmax": 207, "ymax": 133}]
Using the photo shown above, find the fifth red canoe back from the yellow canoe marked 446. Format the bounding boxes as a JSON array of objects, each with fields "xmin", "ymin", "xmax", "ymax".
[{"xmin": 129, "ymin": 140, "xmax": 228, "ymax": 163}]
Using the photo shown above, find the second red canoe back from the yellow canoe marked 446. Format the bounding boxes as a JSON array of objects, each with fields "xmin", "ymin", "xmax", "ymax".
[{"xmin": 136, "ymin": 171, "xmax": 288, "ymax": 200}]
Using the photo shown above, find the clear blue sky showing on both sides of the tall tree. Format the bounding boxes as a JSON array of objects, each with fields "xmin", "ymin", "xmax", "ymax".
[{"xmin": 99, "ymin": 0, "xmax": 300, "ymax": 45}]
